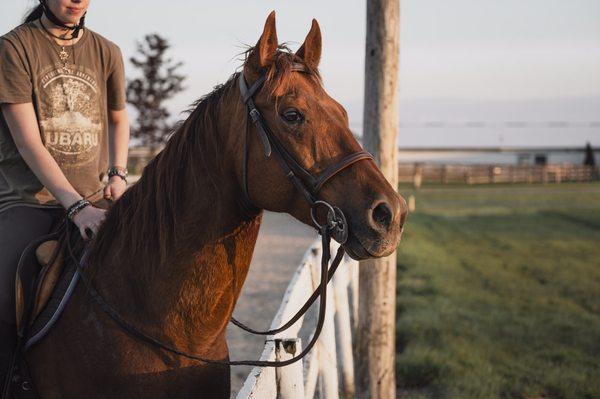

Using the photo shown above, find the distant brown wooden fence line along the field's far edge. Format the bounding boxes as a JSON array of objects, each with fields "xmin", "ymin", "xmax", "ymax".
[{"xmin": 398, "ymin": 163, "xmax": 600, "ymax": 187}]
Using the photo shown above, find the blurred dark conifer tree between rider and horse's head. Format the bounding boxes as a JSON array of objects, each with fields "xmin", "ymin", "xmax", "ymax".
[{"xmin": 127, "ymin": 33, "xmax": 185, "ymax": 151}]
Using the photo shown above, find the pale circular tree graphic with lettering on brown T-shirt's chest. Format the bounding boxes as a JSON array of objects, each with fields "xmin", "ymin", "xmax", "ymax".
[{"xmin": 39, "ymin": 63, "xmax": 103, "ymax": 166}]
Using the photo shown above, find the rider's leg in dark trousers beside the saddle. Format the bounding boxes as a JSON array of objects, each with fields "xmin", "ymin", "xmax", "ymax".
[{"xmin": 0, "ymin": 205, "xmax": 60, "ymax": 385}]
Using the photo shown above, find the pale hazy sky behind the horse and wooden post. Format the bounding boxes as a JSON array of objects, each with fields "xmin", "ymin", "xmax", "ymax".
[{"xmin": 0, "ymin": 0, "xmax": 600, "ymax": 147}]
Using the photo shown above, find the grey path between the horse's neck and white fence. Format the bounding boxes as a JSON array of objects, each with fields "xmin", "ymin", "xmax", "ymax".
[{"xmin": 227, "ymin": 212, "xmax": 316, "ymax": 397}]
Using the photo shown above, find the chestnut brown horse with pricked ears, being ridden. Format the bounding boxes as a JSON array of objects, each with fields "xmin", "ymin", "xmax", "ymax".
[{"xmin": 27, "ymin": 13, "xmax": 406, "ymax": 398}]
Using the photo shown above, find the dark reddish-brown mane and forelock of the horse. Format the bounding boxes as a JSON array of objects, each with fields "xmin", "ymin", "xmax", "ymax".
[{"xmin": 89, "ymin": 44, "xmax": 321, "ymax": 276}]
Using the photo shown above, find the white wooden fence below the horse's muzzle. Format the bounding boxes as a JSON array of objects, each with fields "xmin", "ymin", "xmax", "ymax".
[{"xmin": 237, "ymin": 240, "xmax": 358, "ymax": 399}]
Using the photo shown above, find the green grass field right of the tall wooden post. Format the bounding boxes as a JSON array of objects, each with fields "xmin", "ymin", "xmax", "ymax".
[{"xmin": 396, "ymin": 184, "xmax": 600, "ymax": 399}]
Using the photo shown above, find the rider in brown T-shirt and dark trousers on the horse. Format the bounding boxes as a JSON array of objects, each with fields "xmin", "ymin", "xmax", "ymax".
[{"xmin": 0, "ymin": 0, "xmax": 129, "ymax": 386}]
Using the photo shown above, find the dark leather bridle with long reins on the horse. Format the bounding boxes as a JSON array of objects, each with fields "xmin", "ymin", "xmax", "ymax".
[{"xmin": 65, "ymin": 64, "xmax": 373, "ymax": 367}]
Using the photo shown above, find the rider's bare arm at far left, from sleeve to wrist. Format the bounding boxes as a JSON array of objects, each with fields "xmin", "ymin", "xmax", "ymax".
[{"xmin": 0, "ymin": 102, "xmax": 82, "ymax": 208}]
